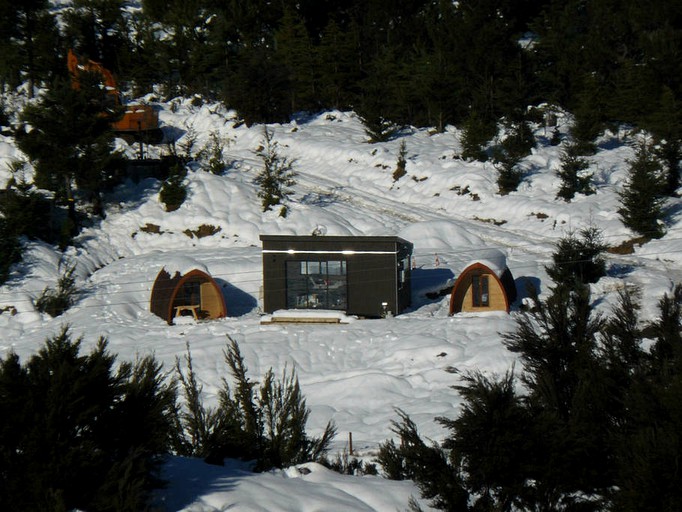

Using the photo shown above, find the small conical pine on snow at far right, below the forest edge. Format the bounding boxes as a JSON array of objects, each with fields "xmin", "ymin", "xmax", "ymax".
[{"xmin": 618, "ymin": 143, "xmax": 664, "ymax": 238}]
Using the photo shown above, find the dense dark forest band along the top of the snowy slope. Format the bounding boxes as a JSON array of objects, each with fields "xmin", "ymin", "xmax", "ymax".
[{"xmin": 0, "ymin": 0, "xmax": 682, "ymax": 139}]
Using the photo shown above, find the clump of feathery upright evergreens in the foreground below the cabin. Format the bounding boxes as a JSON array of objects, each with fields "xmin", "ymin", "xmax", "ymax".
[{"xmin": 176, "ymin": 339, "xmax": 336, "ymax": 471}]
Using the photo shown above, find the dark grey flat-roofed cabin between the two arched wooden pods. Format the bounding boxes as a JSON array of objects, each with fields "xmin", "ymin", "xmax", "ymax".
[{"xmin": 260, "ymin": 235, "xmax": 412, "ymax": 317}]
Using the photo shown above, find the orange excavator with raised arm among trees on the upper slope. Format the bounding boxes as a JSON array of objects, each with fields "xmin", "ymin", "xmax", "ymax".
[{"xmin": 67, "ymin": 50, "xmax": 163, "ymax": 144}]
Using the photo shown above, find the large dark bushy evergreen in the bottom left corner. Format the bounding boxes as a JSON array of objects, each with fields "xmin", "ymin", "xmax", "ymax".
[{"xmin": 0, "ymin": 328, "xmax": 175, "ymax": 512}]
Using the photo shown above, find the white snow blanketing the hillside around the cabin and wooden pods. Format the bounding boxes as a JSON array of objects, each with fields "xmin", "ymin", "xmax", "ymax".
[{"xmin": 0, "ymin": 94, "xmax": 682, "ymax": 512}]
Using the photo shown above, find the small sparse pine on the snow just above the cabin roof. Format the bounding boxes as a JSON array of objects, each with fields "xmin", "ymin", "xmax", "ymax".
[{"xmin": 256, "ymin": 127, "xmax": 296, "ymax": 217}]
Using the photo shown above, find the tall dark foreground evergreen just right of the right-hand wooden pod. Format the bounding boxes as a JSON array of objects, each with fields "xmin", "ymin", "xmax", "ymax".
[{"xmin": 504, "ymin": 287, "xmax": 617, "ymax": 510}]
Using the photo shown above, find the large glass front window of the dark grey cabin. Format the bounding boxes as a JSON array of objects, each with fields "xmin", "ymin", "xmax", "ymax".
[{"xmin": 286, "ymin": 260, "xmax": 348, "ymax": 310}]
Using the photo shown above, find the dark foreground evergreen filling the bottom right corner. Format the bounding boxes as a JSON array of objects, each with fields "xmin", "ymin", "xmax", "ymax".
[{"xmin": 613, "ymin": 285, "xmax": 682, "ymax": 512}]
